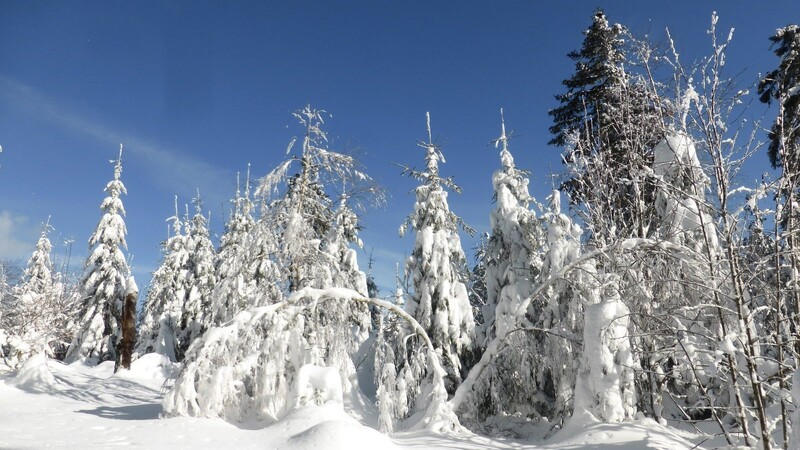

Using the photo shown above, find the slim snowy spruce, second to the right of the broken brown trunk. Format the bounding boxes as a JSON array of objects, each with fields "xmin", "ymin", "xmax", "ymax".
[{"xmin": 175, "ymin": 192, "xmax": 217, "ymax": 361}]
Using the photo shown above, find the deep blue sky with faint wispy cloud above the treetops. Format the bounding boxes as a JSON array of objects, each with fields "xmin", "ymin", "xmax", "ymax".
[{"xmin": 0, "ymin": 0, "xmax": 800, "ymax": 294}]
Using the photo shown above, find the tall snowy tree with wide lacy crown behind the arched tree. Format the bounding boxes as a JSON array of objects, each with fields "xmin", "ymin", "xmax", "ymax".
[{"xmin": 250, "ymin": 106, "xmax": 381, "ymax": 384}]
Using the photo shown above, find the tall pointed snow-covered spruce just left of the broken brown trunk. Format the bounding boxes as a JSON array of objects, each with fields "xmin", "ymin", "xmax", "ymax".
[{"xmin": 65, "ymin": 145, "xmax": 130, "ymax": 362}]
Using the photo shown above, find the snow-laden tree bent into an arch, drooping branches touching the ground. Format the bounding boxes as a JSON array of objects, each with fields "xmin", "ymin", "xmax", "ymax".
[{"xmin": 164, "ymin": 287, "xmax": 462, "ymax": 431}]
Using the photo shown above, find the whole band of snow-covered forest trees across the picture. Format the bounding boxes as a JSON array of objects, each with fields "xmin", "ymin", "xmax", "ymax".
[{"xmin": 0, "ymin": 11, "xmax": 800, "ymax": 448}]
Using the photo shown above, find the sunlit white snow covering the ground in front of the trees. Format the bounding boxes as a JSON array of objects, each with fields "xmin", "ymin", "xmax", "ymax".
[{"xmin": 0, "ymin": 354, "xmax": 702, "ymax": 450}]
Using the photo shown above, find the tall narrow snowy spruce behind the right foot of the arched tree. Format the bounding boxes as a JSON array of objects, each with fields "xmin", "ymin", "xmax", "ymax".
[{"xmin": 399, "ymin": 113, "xmax": 477, "ymax": 393}]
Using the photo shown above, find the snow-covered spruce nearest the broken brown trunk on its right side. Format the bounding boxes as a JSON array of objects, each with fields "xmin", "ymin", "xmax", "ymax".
[{"xmin": 136, "ymin": 196, "xmax": 190, "ymax": 361}]
